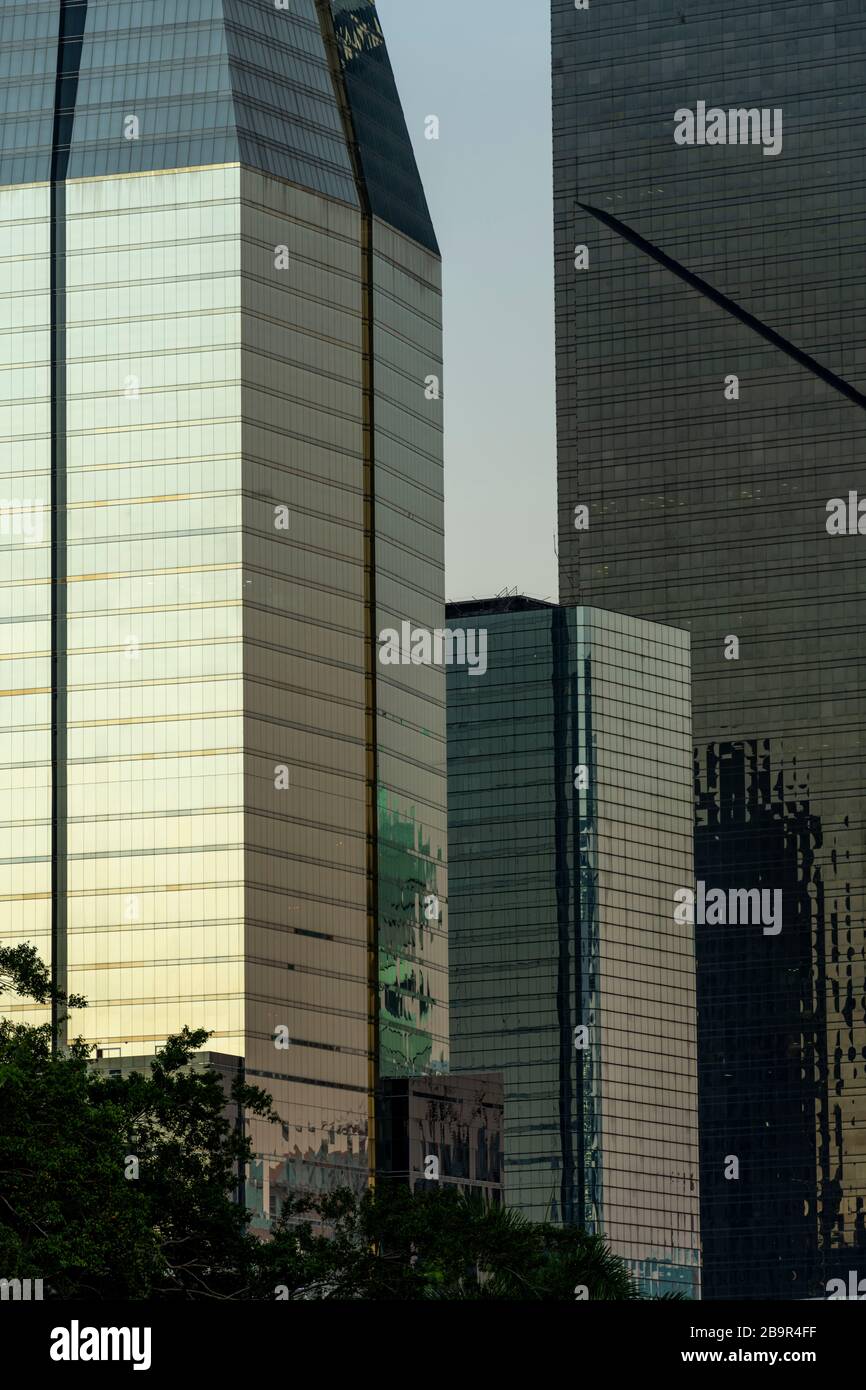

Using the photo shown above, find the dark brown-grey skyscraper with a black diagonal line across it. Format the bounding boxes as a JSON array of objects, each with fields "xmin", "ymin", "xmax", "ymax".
[{"xmin": 552, "ymin": 0, "xmax": 866, "ymax": 1298}]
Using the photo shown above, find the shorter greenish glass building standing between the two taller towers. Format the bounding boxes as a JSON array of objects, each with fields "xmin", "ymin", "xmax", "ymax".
[{"xmin": 448, "ymin": 599, "xmax": 701, "ymax": 1295}]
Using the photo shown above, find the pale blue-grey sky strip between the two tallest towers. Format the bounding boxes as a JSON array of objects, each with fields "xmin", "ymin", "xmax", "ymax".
[{"xmin": 377, "ymin": 0, "xmax": 557, "ymax": 599}]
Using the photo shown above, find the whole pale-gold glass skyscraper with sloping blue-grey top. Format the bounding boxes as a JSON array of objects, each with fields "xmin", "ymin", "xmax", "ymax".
[{"xmin": 0, "ymin": 0, "xmax": 448, "ymax": 1206}]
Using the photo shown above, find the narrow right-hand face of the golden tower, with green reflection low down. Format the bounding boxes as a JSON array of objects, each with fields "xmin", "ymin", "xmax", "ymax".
[{"xmin": 371, "ymin": 218, "xmax": 448, "ymax": 1076}]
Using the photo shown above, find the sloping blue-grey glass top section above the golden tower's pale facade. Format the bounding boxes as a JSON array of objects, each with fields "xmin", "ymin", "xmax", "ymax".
[{"xmin": 0, "ymin": 0, "xmax": 358, "ymax": 198}]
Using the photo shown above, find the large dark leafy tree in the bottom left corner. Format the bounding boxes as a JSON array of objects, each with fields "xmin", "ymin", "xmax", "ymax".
[{"xmin": 0, "ymin": 945, "xmax": 277, "ymax": 1298}]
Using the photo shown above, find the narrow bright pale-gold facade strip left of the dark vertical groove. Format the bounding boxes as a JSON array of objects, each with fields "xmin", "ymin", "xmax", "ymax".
[{"xmin": 0, "ymin": 185, "xmax": 53, "ymax": 989}]
